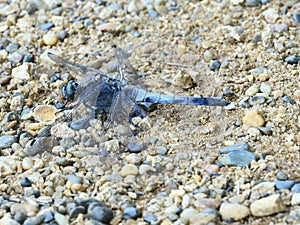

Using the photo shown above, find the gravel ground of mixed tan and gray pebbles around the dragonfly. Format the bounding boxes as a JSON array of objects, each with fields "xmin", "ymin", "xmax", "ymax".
[{"xmin": 0, "ymin": 0, "xmax": 300, "ymax": 225}]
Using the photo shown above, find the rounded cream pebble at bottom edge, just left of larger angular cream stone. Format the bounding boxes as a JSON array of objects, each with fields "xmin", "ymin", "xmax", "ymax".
[{"xmin": 220, "ymin": 203, "xmax": 250, "ymax": 221}]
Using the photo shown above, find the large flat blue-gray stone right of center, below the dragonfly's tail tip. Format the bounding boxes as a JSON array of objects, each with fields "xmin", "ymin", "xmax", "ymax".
[{"xmin": 219, "ymin": 150, "xmax": 256, "ymax": 167}]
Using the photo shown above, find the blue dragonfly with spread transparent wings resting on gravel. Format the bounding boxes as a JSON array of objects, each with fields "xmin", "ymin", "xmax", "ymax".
[{"xmin": 48, "ymin": 46, "xmax": 229, "ymax": 134}]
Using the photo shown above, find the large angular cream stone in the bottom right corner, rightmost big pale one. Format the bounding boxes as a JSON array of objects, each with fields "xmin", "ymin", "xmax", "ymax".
[{"xmin": 250, "ymin": 194, "xmax": 286, "ymax": 216}]
